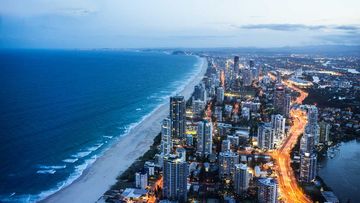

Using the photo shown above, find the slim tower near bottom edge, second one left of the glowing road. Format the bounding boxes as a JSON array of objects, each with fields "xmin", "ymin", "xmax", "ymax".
[{"xmin": 234, "ymin": 164, "xmax": 250, "ymax": 195}]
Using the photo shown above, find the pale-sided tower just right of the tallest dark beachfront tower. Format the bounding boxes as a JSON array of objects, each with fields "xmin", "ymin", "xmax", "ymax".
[{"xmin": 196, "ymin": 120, "xmax": 213, "ymax": 156}]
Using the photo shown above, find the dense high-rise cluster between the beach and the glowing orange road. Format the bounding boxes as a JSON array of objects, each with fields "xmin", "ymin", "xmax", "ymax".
[{"xmin": 118, "ymin": 57, "xmax": 288, "ymax": 203}]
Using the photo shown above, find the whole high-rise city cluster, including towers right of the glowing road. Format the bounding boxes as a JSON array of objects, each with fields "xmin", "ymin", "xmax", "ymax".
[{"xmin": 113, "ymin": 52, "xmax": 358, "ymax": 203}]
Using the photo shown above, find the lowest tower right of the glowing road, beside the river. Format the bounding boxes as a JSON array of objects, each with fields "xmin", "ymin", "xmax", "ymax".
[{"xmin": 300, "ymin": 153, "xmax": 317, "ymax": 183}]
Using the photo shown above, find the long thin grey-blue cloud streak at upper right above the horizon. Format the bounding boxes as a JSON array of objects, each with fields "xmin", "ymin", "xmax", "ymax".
[{"xmin": 232, "ymin": 24, "xmax": 360, "ymax": 31}]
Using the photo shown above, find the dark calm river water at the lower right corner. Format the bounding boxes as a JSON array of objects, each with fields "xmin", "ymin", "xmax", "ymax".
[{"xmin": 319, "ymin": 140, "xmax": 360, "ymax": 202}]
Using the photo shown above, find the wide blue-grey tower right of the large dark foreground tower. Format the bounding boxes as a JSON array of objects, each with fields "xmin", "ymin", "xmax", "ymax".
[{"xmin": 219, "ymin": 151, "xmax": 239, "ymax": 178}]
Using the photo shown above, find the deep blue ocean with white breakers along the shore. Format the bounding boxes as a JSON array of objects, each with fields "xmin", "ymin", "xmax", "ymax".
[{"xmin": 0, "ymin": 50, "xmax": 200, "ymax": 202}]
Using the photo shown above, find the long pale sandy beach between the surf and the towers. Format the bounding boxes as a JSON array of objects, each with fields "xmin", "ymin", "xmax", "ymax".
[{"xmin": 42, "ymin": 58, "xmax": 207, "ymax": 203}]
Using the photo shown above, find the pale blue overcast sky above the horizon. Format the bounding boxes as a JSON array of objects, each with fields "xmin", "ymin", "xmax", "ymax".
[{"xmin": 0, "ymin": 0, "xmax": 360, "ymax": 48}]
